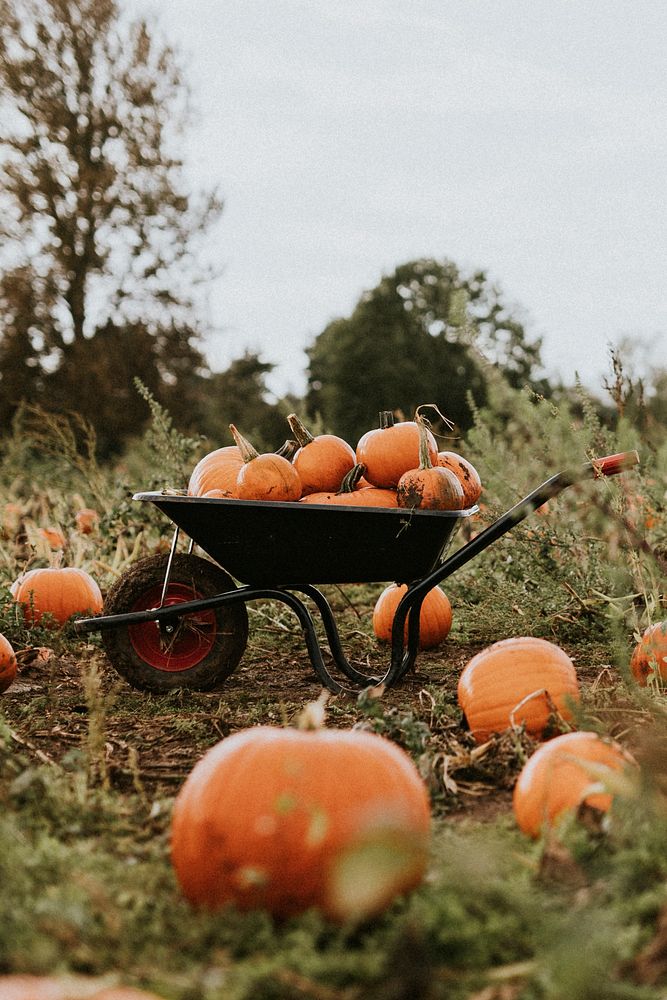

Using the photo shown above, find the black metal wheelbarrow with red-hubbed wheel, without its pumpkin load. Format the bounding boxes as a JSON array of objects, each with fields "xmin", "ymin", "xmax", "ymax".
[{"xmin": 75, "ymin": 451, "xmax": 639, "ymax": 692}]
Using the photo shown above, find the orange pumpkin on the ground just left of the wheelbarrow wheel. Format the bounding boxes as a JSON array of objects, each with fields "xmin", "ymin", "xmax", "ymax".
[{"xmin": 12, "ymin": 566, "xmax": 103, "ymax": 625}]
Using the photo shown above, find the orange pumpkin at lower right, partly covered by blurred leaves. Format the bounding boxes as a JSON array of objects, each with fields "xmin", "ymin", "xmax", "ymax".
[{"xmin": 513, "ymin": 732, "xmax": 632, "ymax": 837}]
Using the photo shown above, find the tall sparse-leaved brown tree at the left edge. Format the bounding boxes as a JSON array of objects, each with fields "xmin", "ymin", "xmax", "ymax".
[{"xmin": 0, "ymin": 0, "xmax": 221, "ymax": 445}]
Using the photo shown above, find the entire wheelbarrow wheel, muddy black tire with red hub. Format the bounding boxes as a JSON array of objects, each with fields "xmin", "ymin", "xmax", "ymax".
[{"xmin": 102, "ymin": 553, "xmax": 248, "ymax": 692}]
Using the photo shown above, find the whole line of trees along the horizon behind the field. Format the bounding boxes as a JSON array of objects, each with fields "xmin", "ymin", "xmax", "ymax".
[{"xmin": 0, "ymin": 0, "xmax": 664, "ymax": 456}]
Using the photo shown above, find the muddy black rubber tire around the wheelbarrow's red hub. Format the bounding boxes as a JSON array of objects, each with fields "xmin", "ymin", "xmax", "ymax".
[{"xmin": 102, "ymin": 553, "xmax": 248, "ymax": 692}]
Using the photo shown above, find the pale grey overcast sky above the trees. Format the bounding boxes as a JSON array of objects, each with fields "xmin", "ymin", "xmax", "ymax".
[{"xmin": 146, "ymin": 0, "xmax": 667, "ymax": 392}]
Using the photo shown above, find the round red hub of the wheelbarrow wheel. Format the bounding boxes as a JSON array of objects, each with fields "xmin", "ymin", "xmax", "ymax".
[{"xmin": 127, "ymin": 583, "xmax": 217, "ymax": 672}]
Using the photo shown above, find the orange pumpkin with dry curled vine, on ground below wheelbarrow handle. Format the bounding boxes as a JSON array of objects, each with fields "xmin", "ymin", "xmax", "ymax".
[{"xmin": 458, "ymin": 636, "xmax": 579, "ymax": 743}]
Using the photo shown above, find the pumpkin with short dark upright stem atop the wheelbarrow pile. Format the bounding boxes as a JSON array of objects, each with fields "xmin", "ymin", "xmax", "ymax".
[{"xmin": 356, "ymin": 410, "xmax": 438, "ymax": 489}]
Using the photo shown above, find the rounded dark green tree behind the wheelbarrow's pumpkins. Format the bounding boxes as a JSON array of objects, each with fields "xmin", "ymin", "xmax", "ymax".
[{"xmin": 306, "ymin": 259, "xmax": 545, "ymax": 444}]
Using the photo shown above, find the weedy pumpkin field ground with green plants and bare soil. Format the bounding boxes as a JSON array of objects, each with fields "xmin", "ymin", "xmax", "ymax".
[{"xmin": 0, "ymin": 378, "xmax": 667, "ymax": 1000}]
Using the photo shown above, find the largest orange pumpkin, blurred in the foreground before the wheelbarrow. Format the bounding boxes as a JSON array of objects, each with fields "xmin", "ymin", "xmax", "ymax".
[{"xmin": 171, "ymin": 726, "xmax": 430, "ymax": 920}]
